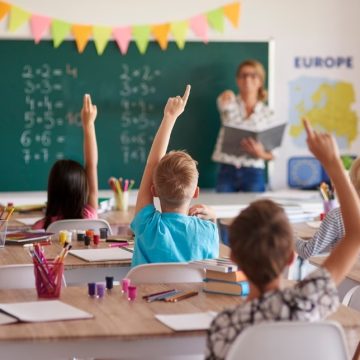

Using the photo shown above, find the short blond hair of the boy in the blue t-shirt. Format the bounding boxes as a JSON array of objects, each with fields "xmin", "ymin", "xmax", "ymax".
[{"xmin": 153, "ymin": 151, "xmax": 199, "ymax": 207}]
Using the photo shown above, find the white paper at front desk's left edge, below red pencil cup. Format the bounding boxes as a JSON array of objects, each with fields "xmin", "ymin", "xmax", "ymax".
[{"xmin": 0, "ymin": 300, "xmax": 93, "ymax": 323}]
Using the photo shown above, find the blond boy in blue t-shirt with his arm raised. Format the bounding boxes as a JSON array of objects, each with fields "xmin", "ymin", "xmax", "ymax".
[{"xmin": 131, "ymin": 85, "xmax": 219, "ymax": 266}]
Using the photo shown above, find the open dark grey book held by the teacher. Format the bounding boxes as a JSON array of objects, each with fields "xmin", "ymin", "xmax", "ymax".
[{"xmin": 222, "ymin": 124, "xmax": 286, "ymax": 156}]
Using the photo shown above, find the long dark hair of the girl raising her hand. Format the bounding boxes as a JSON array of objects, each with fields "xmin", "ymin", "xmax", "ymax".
[{"xmin": 44, "ymin": 160, "xmax": 89, "ymax": 229}]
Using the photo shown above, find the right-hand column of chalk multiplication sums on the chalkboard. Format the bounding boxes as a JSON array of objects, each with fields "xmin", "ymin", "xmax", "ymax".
[{"xmin": 119, "ymin": 64, "xmax": 161, "ymax": 164}]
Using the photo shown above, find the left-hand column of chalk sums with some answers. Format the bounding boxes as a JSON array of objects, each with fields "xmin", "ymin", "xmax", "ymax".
[{"xmin": 19, "ymin": 63, "xmax": 77, "ymax": 165}]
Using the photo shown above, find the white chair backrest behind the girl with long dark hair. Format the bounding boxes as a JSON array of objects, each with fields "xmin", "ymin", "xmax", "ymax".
[{"xmin": 46, "ymin": 219, "xmax": 112, "ymax": 235}]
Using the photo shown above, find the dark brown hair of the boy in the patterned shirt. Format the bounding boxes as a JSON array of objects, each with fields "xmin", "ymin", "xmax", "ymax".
[{"xmin": 229, "ymin": 200, "xmax": 294, "ymax": 292}]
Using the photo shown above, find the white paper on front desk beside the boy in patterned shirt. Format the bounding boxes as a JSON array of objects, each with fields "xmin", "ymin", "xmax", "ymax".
[{"xmin": 155, "ymin": 311, "xmax": 217, "ymax": 331}]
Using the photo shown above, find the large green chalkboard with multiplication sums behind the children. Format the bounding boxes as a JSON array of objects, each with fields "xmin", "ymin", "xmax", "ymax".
[{"xmin": 0, "ymin": 40, "xmax": 269, "ymax": 191}]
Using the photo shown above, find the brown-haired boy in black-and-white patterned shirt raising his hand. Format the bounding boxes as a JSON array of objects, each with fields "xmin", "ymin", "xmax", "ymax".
[{"xmin": 206, "ymin": 120, "xmax": 360, "ymax": 359}]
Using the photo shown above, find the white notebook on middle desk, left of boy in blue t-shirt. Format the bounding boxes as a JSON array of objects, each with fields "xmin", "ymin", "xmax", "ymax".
[{"xmin": 69, "ymin": 248, "xmax": 133, "ymax": 262}]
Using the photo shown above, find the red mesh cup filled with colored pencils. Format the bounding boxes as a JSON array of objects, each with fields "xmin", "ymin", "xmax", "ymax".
[{"xmin": 30, "ymin": 244, "xmax": 71, "ymax": 299}]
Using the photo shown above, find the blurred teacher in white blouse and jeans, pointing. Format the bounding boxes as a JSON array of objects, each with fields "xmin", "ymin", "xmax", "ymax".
[{"xmin": 212, "ymin": 60, "xmax": 274, "ymax": 192}]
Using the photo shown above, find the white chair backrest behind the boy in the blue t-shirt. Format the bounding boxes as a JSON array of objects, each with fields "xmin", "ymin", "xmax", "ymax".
[{"xmin": 126, "ymin": 263, "xmax": 204, "ymax": 284}]
